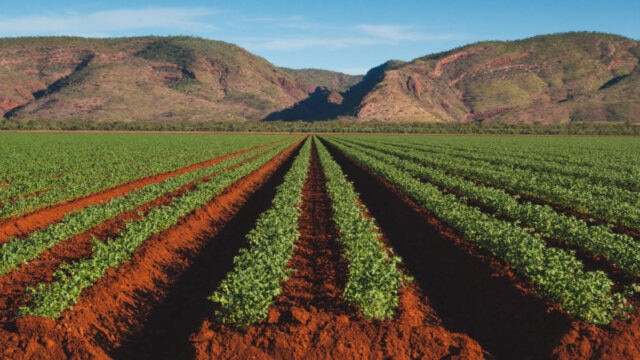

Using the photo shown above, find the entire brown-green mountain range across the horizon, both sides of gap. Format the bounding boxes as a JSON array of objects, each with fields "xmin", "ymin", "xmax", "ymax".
[{"xmin": 0, "ymin": 32, "xmax": 640, "ymax": 124}]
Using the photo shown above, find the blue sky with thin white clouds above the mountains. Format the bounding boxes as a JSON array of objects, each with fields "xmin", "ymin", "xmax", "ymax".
[{"xmin": 0, "ymin": 0, "xmax": 640, "ymax": 74}]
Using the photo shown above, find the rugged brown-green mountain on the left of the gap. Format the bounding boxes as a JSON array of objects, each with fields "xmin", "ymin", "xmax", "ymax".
[{"xmin": 0, "ymin": 37, "xmax": 361, "ymax": 121}]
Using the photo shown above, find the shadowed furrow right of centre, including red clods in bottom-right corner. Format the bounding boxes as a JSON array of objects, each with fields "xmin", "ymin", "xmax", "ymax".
[{"xmin": 322, "ymin": 139, "xmax": 640, "ymax": 359}]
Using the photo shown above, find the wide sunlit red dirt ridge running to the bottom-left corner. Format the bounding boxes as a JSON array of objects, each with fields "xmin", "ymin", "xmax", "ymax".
[{"xmin": 0, "ymin": 139, "xmax": 299, "ymax": 359}]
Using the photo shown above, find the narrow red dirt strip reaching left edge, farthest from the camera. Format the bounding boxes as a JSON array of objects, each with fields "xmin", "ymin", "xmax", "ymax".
[{"xmin": 0, "ymin": 144, "xmax": 278, "ymax": 244}]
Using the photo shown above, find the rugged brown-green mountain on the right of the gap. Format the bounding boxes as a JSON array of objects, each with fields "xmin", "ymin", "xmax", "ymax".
[{"xmin": 341, "ymin": 33, "xmax": 640, "ymax": 123}]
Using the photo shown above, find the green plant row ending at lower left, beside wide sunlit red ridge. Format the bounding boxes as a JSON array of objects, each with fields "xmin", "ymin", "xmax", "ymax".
[{"xmin": 19, "ymin": 141, "xmax": 300, "ymax": 318}]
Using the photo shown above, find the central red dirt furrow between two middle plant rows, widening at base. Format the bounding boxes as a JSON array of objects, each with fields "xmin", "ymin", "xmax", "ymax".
[{"xmin": 191, "ymin": 142, "xmax": 482, "ymax": 359}]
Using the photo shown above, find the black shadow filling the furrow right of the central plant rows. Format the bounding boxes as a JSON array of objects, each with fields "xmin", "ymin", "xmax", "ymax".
[{"xmin": 323, "ymin": 140, "xmax": 570, "ymax": 359}]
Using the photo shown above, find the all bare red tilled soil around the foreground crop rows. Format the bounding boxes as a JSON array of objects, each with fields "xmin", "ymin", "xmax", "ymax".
[{"xmin": 0, "ymin": 136, "xmax": 640, "ymax": 359}]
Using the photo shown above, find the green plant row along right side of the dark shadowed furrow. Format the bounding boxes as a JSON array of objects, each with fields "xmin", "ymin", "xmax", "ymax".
[{"xmin": 329, "ymin": 139, "xmax": 630, "ymax": 324}]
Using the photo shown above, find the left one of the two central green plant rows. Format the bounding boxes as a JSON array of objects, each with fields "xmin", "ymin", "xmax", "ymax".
[{"xmin": 209, "ymin": 139, "xmax": 311, "ymax": 326}]
